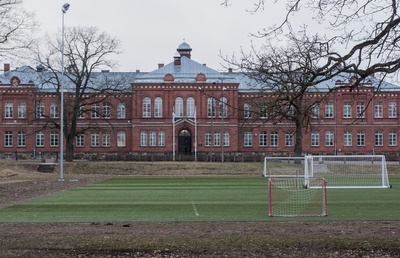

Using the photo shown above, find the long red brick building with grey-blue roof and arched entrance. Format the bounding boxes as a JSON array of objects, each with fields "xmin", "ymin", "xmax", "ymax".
[{"xmin": 0, "ymin": 43, "xmax": 400, "ymax": 160}]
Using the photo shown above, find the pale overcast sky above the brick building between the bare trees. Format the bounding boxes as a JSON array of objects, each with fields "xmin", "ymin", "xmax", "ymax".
[{"xmin": 24, "ymin": 0, "xmax": 282, "ymax": 72}]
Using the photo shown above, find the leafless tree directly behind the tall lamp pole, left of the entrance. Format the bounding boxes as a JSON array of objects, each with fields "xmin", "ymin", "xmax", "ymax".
[{"xmin": 37, "ymin": 27, "xmax": 131, "ymax": 161}]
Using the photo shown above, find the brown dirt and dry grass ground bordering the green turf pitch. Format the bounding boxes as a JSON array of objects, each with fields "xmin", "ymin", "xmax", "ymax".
[{"xmin": 0, "ymin": 162, "xmax": 400, "ymax": 257}]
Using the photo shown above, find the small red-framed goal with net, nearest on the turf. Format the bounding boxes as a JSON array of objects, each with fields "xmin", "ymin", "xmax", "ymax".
[{"xmin": 268, "ymin": 178, "xmax": 328, "ymax": 217}]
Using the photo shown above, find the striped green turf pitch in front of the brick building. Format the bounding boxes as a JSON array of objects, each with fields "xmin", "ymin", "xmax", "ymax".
[{"xmin": 0, "ymin": 176, "xmax": 400, "ymax": 222}]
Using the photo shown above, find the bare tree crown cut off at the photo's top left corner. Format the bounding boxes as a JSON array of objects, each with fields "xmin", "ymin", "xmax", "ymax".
[{"xmin": 0, "ymin": 0, "xmax": 37, "ymax": 60}]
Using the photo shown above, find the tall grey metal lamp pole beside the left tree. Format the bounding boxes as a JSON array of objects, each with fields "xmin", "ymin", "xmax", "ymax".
[{"xmin": 59, "ymin": 3, "xmax": 70, "ymax": 181}]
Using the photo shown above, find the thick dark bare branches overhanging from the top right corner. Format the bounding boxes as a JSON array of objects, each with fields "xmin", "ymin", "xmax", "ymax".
[{"xmin": 222, "ymin": 0, "xmax": 400, "ymax": 82}]
